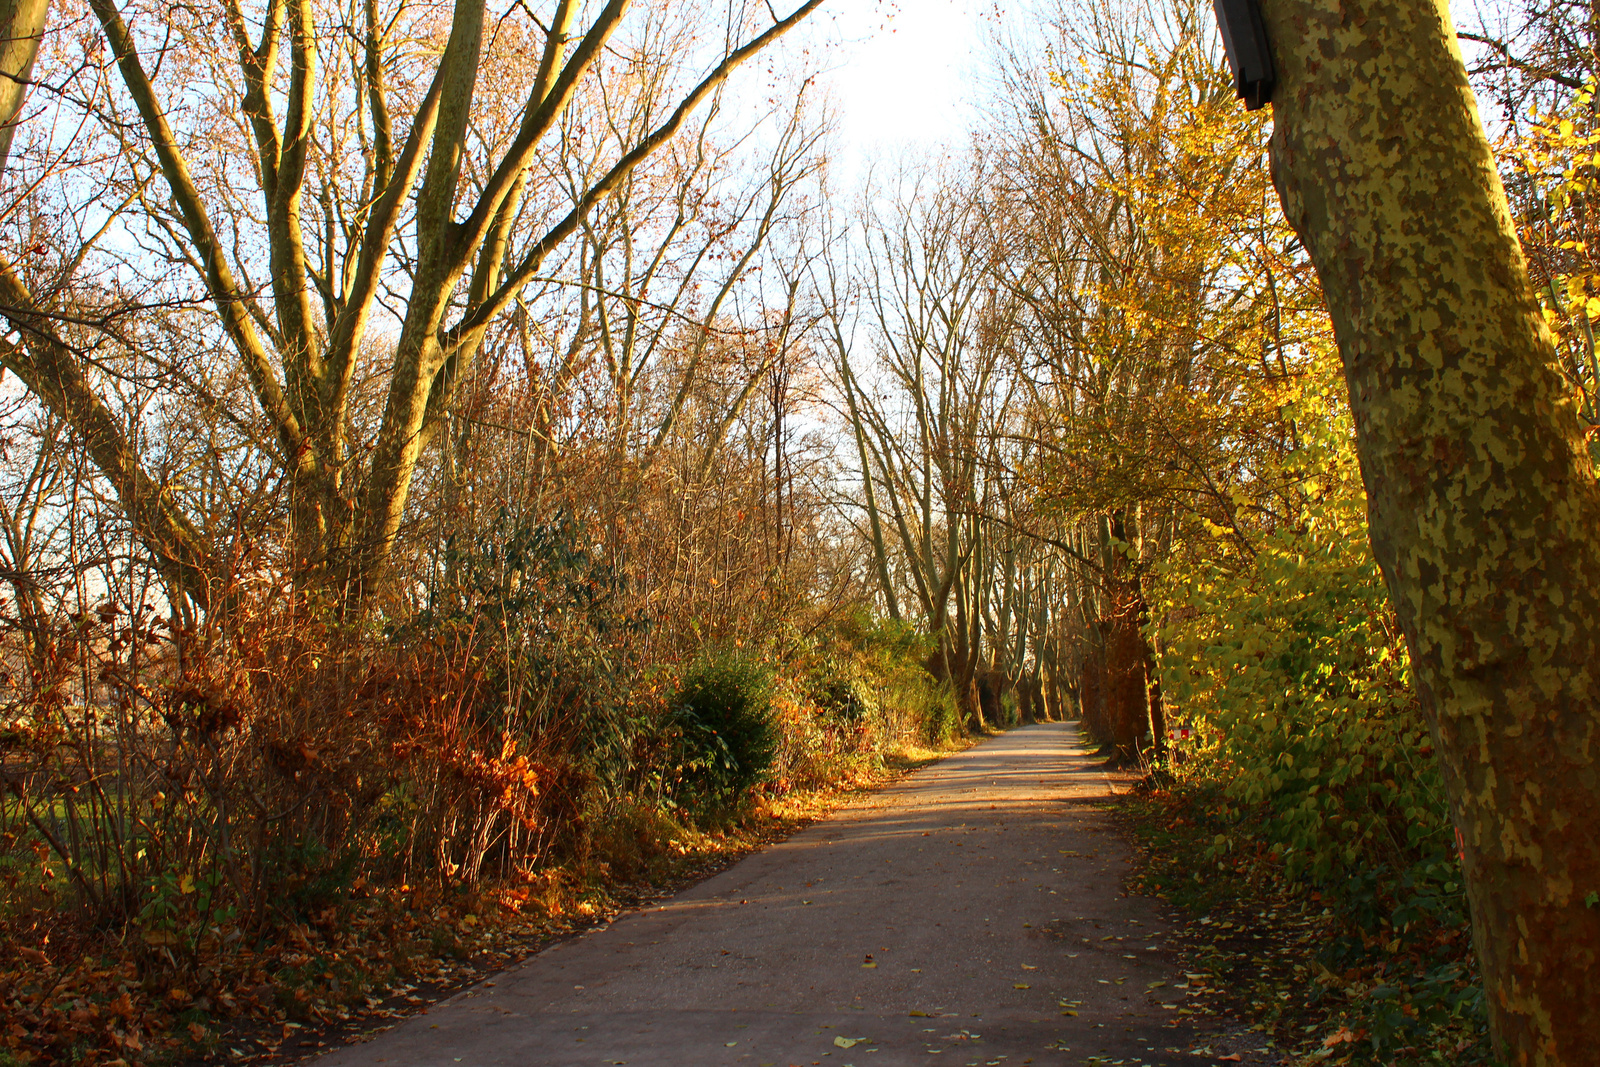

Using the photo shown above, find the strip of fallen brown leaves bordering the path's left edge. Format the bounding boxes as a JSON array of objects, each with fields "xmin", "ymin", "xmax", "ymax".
[{"xmin": 0, "ymin": 713, "xmax": 947, "ymax": 1067}]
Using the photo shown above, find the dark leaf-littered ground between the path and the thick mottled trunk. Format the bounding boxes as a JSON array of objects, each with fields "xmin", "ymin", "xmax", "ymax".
[{"xmin": 1120, "ymin": 785, "xmax": 1494, "ymax": 1067}]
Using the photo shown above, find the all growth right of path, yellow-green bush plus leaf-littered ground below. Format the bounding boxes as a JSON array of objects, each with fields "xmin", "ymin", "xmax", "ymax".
[{"xmin": 1130, "ymin": 412, "xmax": 1488, "ymax": 1065}]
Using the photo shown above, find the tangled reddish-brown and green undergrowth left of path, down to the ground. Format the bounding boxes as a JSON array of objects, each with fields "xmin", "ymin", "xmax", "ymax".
[{"xmin": 0, "ymin": 502, "xmax": 954, "ymax": 1065}]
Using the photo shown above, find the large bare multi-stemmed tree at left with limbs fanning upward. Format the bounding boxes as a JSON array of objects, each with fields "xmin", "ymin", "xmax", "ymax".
[{"xmin": 0, "ymin": 0, "xmax": 821, "ymax": 603}]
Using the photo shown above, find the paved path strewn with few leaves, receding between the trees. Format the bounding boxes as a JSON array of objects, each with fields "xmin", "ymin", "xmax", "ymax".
[{"xmin": 318, "ymin": 725, "xmax": 1197, "ymax": 1067}]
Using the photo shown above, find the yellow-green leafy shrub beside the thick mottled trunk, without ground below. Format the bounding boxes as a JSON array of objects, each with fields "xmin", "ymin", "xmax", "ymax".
[{"xmin": 1162, "ymin": 467, "xmax": 1461, "ymax": 920}]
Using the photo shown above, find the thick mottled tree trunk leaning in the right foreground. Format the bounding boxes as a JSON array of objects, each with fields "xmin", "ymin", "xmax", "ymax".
[{"xmin": 1262, "ymin": 0, "xmax": 1600, "ymax": 1067}]
